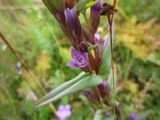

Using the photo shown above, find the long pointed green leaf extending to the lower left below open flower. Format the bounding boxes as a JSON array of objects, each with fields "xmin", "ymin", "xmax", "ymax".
[{"xmin": 35, "ymin": 74, "xmax": 103, "ymax": 107}]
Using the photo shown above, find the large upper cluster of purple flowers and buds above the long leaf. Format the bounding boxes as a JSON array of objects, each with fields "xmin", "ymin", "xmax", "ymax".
[{"xmin": 43, "ymin": 0, "xmax": 111, "ymax": 74}]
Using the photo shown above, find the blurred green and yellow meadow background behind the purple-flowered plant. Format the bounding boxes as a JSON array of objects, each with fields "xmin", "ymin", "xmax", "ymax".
[{"xmin": 0, "ymin": 0, "xmax": 160, "ymax": 120}]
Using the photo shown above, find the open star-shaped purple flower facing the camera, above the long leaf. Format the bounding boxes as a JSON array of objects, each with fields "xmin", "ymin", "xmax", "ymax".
[{"xmin": 67, "ymin": 48, "xmax": 88, "ymax": 68}]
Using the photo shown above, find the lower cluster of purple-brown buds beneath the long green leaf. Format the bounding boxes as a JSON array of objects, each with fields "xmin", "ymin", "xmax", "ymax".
[{"xmin": 84, "ymin": 80, "xmax": 121, "ymax": 120}]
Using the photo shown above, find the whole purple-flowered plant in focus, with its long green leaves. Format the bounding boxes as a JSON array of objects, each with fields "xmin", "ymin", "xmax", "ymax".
[{"xmin": 35, "ymin": 0, "xmax": 144, "ymax": 120}]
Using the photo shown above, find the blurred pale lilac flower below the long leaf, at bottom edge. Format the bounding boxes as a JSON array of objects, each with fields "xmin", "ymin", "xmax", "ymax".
[{"xmin": 56, "ymin": 105, "xmax": 72, "ymax": 120}]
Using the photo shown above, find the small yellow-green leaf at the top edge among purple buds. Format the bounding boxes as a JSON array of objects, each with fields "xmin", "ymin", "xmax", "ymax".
[{"xmin": 74, "ymin": 0, "xmax": 98, "ymax": 11}]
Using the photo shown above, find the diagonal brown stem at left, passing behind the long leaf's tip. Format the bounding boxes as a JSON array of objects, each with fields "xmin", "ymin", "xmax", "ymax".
[{"xmin": 0, "ymin": 32, "xmax": 56, "ymax": 114}]
